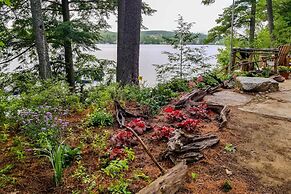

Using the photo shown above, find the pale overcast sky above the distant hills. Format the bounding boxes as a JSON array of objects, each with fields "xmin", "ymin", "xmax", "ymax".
[{"xmin": 109, "ymin": 0, "xmax": 232, "ymax": 33}]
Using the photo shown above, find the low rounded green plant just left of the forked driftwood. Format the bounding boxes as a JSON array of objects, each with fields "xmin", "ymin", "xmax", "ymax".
[{"xmin": 88, "ymin": 109, "xmax": 113, "ymax": 127}]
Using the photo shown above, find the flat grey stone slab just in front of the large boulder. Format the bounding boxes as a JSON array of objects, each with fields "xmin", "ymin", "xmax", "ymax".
[{"xmin": 204, "ymin": 90, "xmax": 252, "ymax": 106}]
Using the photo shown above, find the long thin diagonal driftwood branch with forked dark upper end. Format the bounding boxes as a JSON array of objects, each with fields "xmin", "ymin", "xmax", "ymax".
[{"xmin": 114, "ymin": 101, "xmax": 166, "ymax": 174}]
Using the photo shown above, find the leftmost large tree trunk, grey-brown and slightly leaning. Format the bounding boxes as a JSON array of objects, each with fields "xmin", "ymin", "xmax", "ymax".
[{"xmin": 30, "ymin": 0, "xmax": 51, "ymax": 79}]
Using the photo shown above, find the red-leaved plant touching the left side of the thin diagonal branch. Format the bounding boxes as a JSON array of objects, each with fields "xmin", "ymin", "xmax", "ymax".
[{"xmin": 111, "ymin": 131, "xmax": 136, "ymax": 147}]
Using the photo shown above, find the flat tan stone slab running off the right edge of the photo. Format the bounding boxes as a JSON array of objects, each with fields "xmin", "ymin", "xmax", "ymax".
[{"xmin": 239, "ymin": 100, "xmax": 291, "ymax": 121}]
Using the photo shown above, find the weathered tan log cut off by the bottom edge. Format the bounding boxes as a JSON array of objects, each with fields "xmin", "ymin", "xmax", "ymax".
[{"xmin": 138, "ymin": 161, "xmax": 188, "ymax": 194}]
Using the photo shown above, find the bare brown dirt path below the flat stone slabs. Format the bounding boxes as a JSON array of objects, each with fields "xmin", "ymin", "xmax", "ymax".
[{"xmin": 228, "ymin": 108, "xmax": 291, "ymax": 194}]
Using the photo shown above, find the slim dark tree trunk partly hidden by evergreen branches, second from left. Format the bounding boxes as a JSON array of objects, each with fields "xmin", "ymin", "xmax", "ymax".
[{"xmin": 62, "ymin": 0, "xmax": 75, "ymax": 90}]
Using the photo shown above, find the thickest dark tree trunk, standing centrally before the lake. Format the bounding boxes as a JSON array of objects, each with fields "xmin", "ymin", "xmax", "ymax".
[{"xmin": 116, "ymin": 0, "xmax": 142, "ymax": 85}]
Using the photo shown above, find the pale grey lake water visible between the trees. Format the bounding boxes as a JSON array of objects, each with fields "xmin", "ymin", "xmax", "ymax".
[{"xmin": 94, "ymin": 44, "xmax": 223, "ymax": 86}]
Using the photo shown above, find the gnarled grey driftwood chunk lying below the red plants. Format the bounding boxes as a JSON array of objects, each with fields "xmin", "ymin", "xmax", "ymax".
[{"xmin": 161, "ymin": 130, "xmax": 219, "ymax": 164}]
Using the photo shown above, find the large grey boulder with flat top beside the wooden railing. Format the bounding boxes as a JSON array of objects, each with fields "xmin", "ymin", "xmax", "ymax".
[{"xmin": 236, "ymin": 77, "xmax": 279, "ymax": 92}]
